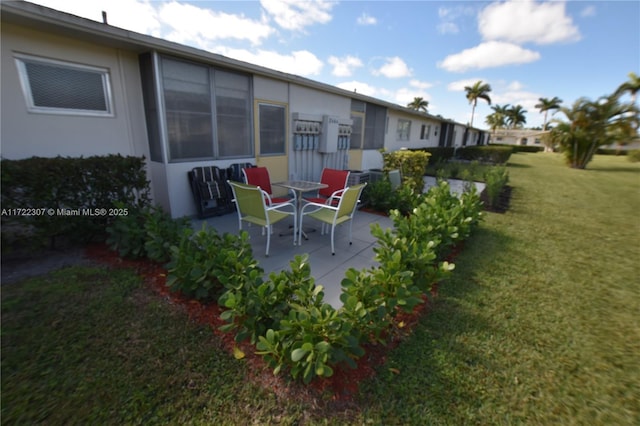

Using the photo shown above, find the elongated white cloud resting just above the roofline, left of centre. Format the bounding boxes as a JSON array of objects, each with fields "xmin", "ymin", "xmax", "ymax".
[{"xmin": 216, "ymin": 47, "xmax": 324, "ymax": 76}]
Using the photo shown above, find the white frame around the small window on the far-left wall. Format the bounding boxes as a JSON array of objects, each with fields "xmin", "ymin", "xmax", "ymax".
[{"xmin": 14, "ymin": 54, "xmax": 114, "ymax": 117}]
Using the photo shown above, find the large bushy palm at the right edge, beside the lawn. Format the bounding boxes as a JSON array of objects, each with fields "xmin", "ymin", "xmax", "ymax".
[{"xmin": 548, "ymin": 94, "xmax": 640, "ymax": 169}]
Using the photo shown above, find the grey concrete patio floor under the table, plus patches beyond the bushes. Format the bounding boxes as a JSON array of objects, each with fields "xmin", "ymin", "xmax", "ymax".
[{"xmin": 192, "ymin": 177, "xmax": 484, "ymax": 308}]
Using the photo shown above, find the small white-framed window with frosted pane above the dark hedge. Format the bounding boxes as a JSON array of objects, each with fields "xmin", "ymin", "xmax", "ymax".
[{"xmin": 16, "ymin": 56, "xmax": 112, "ymax": 115}]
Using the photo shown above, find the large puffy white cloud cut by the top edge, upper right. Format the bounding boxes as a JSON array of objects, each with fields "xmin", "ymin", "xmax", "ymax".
[{"xmin": 478, "ymin": 0, "xmax": 580, "ymax": 44}]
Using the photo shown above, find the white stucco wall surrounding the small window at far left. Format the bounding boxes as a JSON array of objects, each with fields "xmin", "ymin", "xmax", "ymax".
[{"xmin": 0, "ymin": 24, "xmax": 149, "ymax": 159}]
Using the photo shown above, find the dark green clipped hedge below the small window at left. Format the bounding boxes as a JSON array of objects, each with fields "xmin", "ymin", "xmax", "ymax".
[{"xmin": 0, "ymin": 155, "xmax": 149, "ymax": 247}]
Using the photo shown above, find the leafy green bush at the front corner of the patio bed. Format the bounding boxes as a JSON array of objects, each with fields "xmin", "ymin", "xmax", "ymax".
[{"xmin": 219, "ymin": 255, "xmax": 364, "ymax": 383}]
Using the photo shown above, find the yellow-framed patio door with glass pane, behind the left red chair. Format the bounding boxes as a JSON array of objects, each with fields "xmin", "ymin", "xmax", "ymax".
[{"xmin": 254, "ymin": 100, "xmax": 289, "ymax": 195}]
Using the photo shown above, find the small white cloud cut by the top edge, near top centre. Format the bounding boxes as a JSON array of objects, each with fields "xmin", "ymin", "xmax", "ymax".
[{"xmin": 260, "ymin": 0, "xmax": 336, "ymax": 31}]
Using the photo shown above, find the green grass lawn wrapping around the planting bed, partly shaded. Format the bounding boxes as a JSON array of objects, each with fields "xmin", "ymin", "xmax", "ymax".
[{"xmin": 1, "ymin": 153, "xmax": 640, "ymax": 425}]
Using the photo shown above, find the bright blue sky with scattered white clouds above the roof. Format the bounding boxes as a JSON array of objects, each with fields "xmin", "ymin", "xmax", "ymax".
[{"xmin": 33, "ymin": 0, "xmax": 640, "ymax": 128}]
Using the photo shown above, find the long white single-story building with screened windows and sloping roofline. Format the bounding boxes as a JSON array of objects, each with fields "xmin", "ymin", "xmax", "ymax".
[{"xmin": 0, "ymin": 1, "xmax": 488, "ymax": 217}]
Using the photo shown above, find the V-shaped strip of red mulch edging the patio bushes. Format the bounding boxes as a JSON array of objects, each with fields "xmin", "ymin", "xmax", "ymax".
[{"xmin": 86, "ymin": 245, "xmax": 460, "ymax": 408}]
